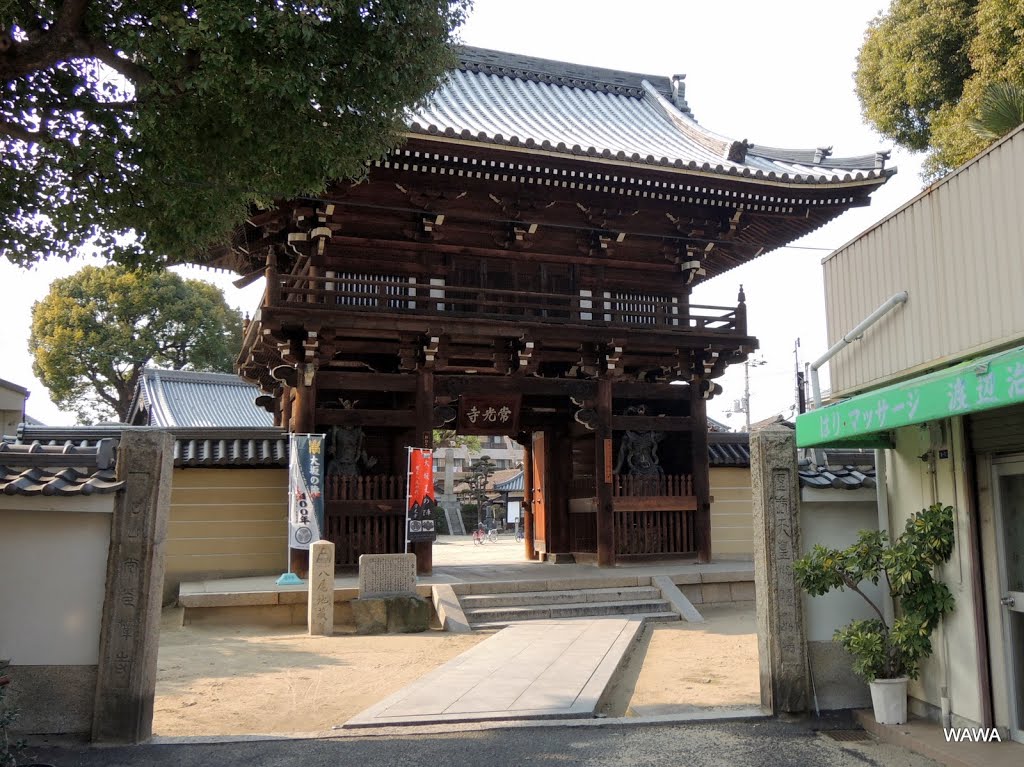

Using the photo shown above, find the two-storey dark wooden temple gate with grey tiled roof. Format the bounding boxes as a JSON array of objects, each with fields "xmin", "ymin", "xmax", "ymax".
[{"xmin": 213, "ymin": 48, "xmax": 894, "ymax": 571}]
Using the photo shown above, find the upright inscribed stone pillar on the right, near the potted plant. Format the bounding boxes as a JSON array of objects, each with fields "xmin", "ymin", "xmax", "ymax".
[{"xmin": 751, "ymin": 424, "xmax": 809, "ymax": 713}]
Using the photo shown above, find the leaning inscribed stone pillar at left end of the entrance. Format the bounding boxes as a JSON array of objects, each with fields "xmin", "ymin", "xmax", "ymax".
[{"xmin": 92, "ymin": 430, "xmax": 174, "ymax": 743}]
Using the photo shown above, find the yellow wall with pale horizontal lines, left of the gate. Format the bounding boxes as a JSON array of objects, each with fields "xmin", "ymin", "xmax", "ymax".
[{"xmin": 164, "ymin": 462, "xmax": 288, "ymax": 603}]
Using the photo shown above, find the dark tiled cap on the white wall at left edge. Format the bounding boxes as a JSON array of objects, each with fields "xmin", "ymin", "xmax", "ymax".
[{"xmin": 0, "ymin": 441, "xmax": 124, "ymax": 496}]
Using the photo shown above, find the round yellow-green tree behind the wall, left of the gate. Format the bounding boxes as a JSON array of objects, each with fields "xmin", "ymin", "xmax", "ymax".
[{"xmin": 29, "ymin": 265, "xmax": 242, "ymax": 423}]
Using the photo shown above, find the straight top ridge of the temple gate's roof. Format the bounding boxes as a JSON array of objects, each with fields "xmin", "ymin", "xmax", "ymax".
[{"xmin": 458, "ymin": 45, "xmax": 672, "ymax": 97}]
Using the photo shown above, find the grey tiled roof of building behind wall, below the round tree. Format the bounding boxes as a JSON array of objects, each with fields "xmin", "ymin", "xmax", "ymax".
[{"xmin": 131, "ymin": 368, "xmax": 273, "ymax": 429}]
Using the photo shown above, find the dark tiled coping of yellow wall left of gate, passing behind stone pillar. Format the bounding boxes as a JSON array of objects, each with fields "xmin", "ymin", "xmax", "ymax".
[{"xmin": 19, "ymin": 425, "xmax": 288, "ymax": 468}]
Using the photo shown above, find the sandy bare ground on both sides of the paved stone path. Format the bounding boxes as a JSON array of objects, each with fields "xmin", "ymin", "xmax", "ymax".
[{"xmin": 153, "ymin": 607, "xmax": 760, "ymax": 736}]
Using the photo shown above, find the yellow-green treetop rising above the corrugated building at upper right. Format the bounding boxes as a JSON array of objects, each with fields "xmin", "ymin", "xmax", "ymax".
[{"xmin": 855, "ymin": 0, "xmax": 1024, "ymax": 177}]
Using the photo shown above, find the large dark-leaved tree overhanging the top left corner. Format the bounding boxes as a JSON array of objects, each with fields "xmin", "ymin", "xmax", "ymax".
[{"xmin": 0, "ymin": 0, "xmax": 471, "ymax": 265}]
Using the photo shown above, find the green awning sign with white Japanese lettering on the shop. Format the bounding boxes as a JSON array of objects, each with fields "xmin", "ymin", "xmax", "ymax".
[{"xmin": 797, "ymin": 346, "xmax": 1024, "ymax": 448}]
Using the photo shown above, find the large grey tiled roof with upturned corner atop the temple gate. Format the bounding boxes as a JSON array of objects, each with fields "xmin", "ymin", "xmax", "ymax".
[{"xmin": 407, "ymin": 47, "xmax": 894, "ymax": 184}]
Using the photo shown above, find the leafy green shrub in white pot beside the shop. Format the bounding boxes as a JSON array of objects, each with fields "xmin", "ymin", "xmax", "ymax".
[{"xmin": 794, "ymin": 504, "xmax": 953, "ymax": 724}]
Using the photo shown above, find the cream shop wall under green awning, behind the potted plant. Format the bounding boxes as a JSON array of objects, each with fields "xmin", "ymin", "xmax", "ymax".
[{"xmin": 887, "ymin": 418, "xmax": 982, "ymax": 724}]
